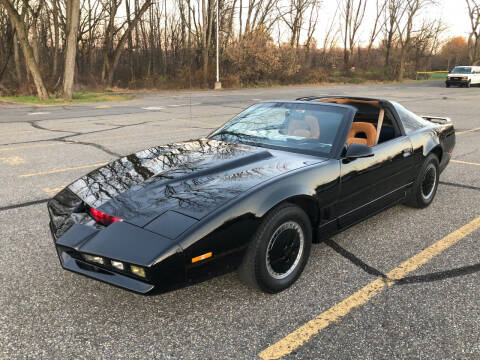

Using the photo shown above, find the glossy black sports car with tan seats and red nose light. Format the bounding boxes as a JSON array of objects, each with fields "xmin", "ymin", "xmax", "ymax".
[{"xmin": 48, "ymin": 97, "xmax": 455, "ymax": 294}]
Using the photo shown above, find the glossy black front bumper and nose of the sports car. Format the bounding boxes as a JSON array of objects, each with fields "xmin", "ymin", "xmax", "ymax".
[{"xmin": 52, "ymin": 222, "xmax": 185, "ymax": 294}]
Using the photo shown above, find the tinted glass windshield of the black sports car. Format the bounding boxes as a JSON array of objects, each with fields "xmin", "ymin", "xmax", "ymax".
[{"xmin": 210, "ymin": 102, "xmax": 350, "ymax": 156}]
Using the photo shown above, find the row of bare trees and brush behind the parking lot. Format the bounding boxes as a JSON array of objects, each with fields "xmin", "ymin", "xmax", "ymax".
[{"xmin": 0, "ymin": 0, "xmax": 480, "ymax": 99}]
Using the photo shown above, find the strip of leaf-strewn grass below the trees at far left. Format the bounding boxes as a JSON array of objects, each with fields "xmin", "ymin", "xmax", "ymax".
[{"xmin": 0, "ymin": 91, "xmax": 132, "ymax": 105}]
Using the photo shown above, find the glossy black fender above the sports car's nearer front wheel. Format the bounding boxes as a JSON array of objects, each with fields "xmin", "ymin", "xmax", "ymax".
[{"xmin": 174, "ymin": 159, "xmax": 340, "ymax": 258}]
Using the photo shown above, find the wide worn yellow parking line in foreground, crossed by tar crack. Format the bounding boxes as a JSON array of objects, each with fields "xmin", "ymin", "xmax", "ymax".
[{"xmin": 258, "ymin": 216, "xmax": 480, "ymax": 360}]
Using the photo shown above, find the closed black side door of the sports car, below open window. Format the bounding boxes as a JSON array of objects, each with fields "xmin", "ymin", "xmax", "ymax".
[{"xmin": 336, "ymin": 116, "xmax": 413, "ymax": 228}]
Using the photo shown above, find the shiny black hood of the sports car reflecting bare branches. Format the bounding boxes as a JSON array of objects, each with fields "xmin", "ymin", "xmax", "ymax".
[{"xmin": 64, "ymin": 139, "xmax": 326, "ymax": 227}]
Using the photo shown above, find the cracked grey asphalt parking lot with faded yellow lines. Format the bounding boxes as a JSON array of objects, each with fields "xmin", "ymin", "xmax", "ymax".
[{"xmin": 0, "ymin": 82, "xmax": 480, "ymax": 359}]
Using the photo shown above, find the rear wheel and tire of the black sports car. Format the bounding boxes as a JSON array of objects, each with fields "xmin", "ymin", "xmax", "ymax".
[{"xmin": 406, "ymin": 154, "xmax": 440, "ymax": 209}]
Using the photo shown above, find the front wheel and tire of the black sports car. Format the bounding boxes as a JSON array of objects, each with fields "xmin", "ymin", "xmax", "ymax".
[{"xmin": 239, "ymin": 203, "xmax": 312, "ymax": 293}]
